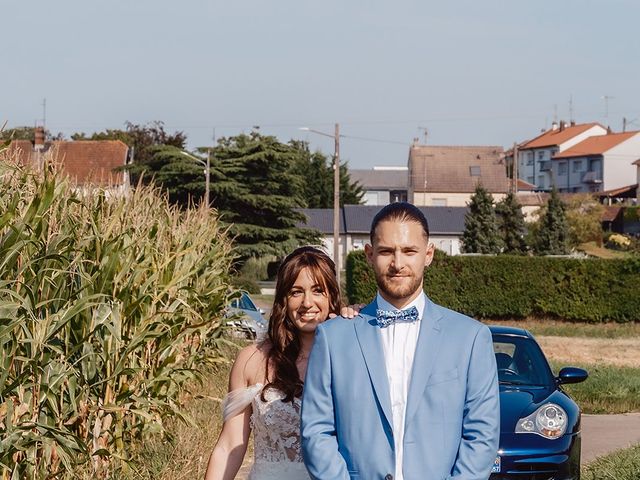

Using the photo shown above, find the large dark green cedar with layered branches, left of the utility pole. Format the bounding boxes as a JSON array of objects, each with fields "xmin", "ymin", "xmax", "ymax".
[{"xmin": 211, "ymin": 132, "xmax": 319, "ymax": 263}]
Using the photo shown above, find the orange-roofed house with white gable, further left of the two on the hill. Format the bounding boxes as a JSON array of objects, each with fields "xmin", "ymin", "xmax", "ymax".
[{"xmin": 518, "ymin": 122, "xmax": 607, "ymax": 190}]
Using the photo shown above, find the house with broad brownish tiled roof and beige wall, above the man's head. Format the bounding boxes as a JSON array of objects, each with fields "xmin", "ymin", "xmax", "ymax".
[{"xmin": 409, "ymin": 144, "xmax": 509, "ymax": 207}]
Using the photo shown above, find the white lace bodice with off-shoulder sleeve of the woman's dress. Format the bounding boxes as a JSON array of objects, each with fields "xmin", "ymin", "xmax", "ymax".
[{"xmin": 223, "ymin": 383, "xmax": 302, "ymax": 464}]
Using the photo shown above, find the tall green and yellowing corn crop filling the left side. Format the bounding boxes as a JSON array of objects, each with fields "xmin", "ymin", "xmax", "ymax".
[{"xmin": 0, "ymin": 152, "xmax": 234, "ymax": 480}]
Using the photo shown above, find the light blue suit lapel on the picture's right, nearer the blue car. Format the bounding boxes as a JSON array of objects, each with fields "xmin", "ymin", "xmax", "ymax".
[{"xmin": 405, "ymin": 298, "xmax": 442, "ymax": 425}]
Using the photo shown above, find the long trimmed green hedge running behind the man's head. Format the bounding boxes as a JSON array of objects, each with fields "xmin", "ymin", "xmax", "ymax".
[{"xmin": 347, "ymin": 251, "xmax": 640, "ymax": 322}]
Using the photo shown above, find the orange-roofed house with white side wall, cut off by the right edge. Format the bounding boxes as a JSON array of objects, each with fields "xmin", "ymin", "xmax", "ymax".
[{"xmin": 551, "ymin": 131, "xmax": 640, "ymax": 192}]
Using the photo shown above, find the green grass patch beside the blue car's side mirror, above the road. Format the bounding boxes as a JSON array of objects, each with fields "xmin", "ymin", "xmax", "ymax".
[{"xmin": 551, "ymin": 362, "xmax": 640, "ymax": 414}]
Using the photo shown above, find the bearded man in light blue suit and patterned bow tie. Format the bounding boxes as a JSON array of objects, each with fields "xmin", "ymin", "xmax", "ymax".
[{"xmin": 302, "ymin": 203, "xmax": 500, "ymax": 480}]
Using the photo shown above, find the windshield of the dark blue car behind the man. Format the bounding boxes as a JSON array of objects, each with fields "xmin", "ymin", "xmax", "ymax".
[{"xmin": 493, "ymin": 335, "xmax": 553, "ymax": 385}]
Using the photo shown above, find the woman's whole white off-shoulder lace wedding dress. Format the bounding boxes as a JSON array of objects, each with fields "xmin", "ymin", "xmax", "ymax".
[{"xmin": 223, "ymin": 383, "xmax": 310, "ymax": 480}]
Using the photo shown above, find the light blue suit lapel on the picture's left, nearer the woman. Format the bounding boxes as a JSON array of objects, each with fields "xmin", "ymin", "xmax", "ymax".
[{"xmin": 354, "ymin": 300, "xmax": 393, "ymax": 426}]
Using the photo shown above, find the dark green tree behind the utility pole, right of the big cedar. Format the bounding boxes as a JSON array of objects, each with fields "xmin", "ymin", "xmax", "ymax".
[{"xmin": 289, "ymin": 140, "xmax": 364, "ymax": 208}]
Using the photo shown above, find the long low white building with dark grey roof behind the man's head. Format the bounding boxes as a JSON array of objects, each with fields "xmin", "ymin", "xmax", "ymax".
[{"xmin": 298, "ymin": 205, "xmax": 468, "ymax": 269}]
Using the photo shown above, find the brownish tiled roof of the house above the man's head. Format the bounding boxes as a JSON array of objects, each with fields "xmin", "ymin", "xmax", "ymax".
[{"xmin": 409, "ymin": 145, "xmax": 509, "ymax": 193}]
